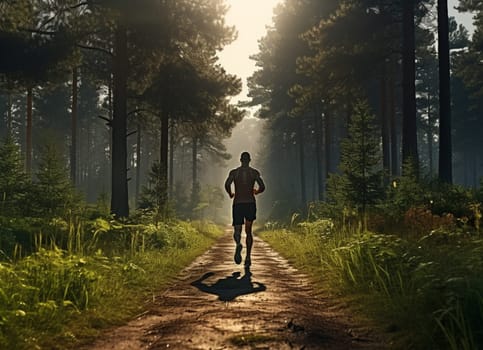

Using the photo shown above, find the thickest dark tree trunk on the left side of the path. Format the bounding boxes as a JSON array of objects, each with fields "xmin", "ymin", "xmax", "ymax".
[{"xmin": 111, "ymin": 20, "xmax": 129, "ymax": 217}]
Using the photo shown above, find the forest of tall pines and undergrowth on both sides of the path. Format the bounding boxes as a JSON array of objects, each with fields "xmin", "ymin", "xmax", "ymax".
[{"xmin": 0, "ymin": 0, "xmax": 483, "ymax": 349}]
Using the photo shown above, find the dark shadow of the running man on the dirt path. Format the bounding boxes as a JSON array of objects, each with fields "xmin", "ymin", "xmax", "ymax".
[{"xmin": 191, "ymin": 266, "xmax": 267, "ymax": 301}]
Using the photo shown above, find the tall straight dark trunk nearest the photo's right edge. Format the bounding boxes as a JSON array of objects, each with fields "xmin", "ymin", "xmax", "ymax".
[{"xmin": 438, "ymin": 0, "xmax": 453, "ymax": 183}]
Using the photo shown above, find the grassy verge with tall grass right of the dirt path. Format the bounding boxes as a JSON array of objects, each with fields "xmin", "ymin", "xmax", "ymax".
[{"xmin": 260, "ymin": 221, "xmax": 483, "ymax": 350}]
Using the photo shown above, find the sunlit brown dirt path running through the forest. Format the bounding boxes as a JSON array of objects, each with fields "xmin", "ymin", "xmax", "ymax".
[{"xmin": 85, "ymin": 231, "xmax": 385, "ymax": 350}]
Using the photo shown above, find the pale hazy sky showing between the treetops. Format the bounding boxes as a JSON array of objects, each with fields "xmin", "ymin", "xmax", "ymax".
[{"xmin": 219, "ymin": 0, "xmax": 472, "ymax": 106}]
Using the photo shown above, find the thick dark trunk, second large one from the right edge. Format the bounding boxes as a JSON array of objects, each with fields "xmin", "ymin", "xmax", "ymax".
[{"xmin": 402, "ymin": 0, "xmax": 419, "ymax": 174}]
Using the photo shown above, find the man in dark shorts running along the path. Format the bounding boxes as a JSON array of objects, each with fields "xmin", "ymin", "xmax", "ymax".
[{"xmin": 225, "ymin": 152, "xmax": 265, "ymax": 266}]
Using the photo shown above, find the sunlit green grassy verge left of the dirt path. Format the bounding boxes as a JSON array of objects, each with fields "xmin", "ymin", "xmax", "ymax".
[{"xmin": 0, "ymin": 222, "xmax": 222, "ymax": 349}]
